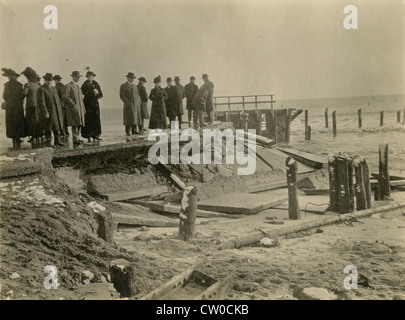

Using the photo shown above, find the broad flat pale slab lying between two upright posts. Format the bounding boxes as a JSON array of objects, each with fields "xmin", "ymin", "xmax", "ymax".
[{"xmin": 197, "ymin": 190, "xmax": 288, "ymax": 214}]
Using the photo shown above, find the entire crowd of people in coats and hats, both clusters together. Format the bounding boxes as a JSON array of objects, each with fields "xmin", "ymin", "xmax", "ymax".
[{"xmin": 2, "ymin": 67, "xmax": 214, "ymax": 148}]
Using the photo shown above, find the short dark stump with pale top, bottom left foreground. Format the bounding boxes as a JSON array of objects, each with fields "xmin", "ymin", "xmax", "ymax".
[{"xmin": 110, "ymin": 259, "xmax": 136, "ymax": 297}]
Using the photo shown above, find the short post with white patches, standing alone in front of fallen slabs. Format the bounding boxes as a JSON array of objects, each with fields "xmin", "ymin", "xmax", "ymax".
[{"xmin": 179, "ymin": 186, "xmax": 197, "ymax": 241}]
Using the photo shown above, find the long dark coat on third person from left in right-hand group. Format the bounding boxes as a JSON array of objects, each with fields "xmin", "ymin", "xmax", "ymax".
[{"xmin": 149, "ymin": 88, "xmax": 168, "ymax": 129}]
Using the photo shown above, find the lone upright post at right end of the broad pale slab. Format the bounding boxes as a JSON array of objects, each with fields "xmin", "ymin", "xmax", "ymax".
[{"xmin": 285, "ymin": 157, "xmax": 301, "ymax": 220}]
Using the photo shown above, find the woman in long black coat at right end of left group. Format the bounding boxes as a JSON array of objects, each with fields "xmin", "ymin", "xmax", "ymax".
[{"xmin": 81, "ymin": 71, "xmax": 103, "ymax": 142}]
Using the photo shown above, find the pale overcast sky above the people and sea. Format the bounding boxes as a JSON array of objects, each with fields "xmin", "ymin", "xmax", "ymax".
[{"xmin": 0, "ymin": 0, "xmax": 405, "ymax": 107}]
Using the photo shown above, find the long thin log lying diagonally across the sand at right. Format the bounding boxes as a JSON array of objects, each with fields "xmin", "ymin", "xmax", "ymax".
[{"xmin": 218, "ymin": 202, "xmax": 405, "ymax": 250}]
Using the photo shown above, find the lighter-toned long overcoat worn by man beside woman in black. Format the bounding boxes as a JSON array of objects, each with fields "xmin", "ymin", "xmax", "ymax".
[{"xmin": 63, "ymin": 81, "xmax": 86, "ymax": 126}]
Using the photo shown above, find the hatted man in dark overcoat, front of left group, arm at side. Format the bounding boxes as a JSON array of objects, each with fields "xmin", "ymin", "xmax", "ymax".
[{"xmin": 37, "ymin": 73, "xmax": 64, "ymax": 147}]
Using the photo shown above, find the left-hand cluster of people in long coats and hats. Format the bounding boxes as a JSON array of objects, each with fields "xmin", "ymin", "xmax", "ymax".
[{"xmin": 2, "ymin": 67, "xmax": 103, "ymax": 149}]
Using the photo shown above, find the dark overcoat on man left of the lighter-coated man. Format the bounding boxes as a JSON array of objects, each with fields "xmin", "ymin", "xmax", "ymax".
[{"xmin": 37, "ymin": 84, "xmax": 63, "ymax": 131}]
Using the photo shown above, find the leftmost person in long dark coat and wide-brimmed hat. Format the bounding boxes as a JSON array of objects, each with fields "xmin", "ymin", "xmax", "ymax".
[{"xmin": 1, "ymin": 68, "xmax": 24, "ymax": 149}]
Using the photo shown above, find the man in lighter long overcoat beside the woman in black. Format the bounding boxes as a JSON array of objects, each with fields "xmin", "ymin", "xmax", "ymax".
[{"xmin": 63, "ymin": 71, "xmax": 85, "ymax": 144}]
